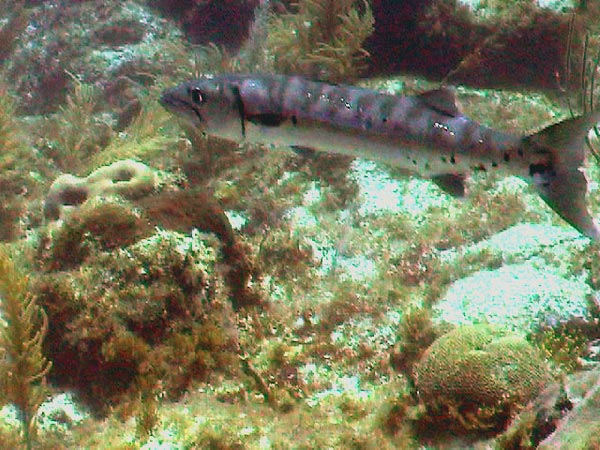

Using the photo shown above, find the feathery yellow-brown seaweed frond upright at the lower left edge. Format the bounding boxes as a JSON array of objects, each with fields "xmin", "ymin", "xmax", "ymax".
[{"xmin": 0, "ymin": 248, "xmax": 52, "ymax": 449}]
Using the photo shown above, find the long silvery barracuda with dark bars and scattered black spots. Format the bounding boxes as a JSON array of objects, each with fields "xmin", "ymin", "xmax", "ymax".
[{"xmin": 161, "ymin": 74, "xmax": 600, "ymax": 240}]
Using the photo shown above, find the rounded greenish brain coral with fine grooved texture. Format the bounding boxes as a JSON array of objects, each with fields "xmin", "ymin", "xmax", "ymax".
[{"xmin": 415, "ymin": 325, "xmax": 550, "ymax": 430}]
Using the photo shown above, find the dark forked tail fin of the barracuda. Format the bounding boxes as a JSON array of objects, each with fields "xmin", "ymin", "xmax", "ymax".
[{"xmin": 524, "ymin": 111, "xmax": 600, "ymax": 240}]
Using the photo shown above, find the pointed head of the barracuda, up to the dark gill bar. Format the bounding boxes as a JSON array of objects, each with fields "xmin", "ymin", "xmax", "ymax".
[{"xmin": 160, "ymin": 77, "xmax": 243, "ymax": 138}]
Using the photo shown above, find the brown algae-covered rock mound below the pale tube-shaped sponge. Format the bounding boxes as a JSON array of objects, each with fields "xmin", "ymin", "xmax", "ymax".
[{"xmin": 34, "ymin": 223, "xmax": 237, "ymax": 414}]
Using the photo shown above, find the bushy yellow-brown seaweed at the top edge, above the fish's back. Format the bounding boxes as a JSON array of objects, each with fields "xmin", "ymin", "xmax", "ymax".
[{"xmin": 267, "ymin": 0, "xmax": 374, "ymax": 81}]
